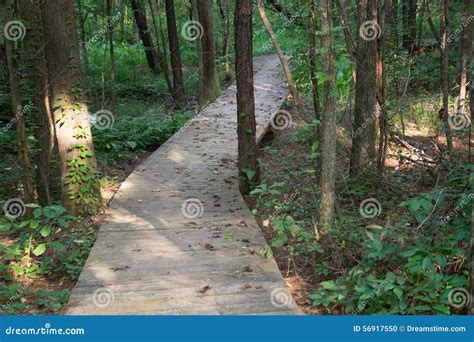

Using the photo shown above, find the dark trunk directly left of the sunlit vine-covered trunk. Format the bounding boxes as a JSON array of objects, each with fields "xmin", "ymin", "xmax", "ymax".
[{"xmin": 18, "ymin": 0, "xmax": 55, "ymax": 206}]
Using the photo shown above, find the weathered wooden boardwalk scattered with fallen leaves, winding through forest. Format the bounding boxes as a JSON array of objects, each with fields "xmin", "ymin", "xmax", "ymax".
[{"xmin": 67, "ymin": 56, "xmax": 302, "ymax": 315}]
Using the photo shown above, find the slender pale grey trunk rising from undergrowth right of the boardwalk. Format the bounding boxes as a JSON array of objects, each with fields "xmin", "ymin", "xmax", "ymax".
[{"xmin": 319, "ymin": 0, "xmax": 336, "ymax": 226}]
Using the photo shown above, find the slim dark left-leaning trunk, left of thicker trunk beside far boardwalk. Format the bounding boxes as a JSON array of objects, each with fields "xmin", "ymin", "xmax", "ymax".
[{"xmin": 166, "ymin": 0, "xmax": 184, "ymax": 105}]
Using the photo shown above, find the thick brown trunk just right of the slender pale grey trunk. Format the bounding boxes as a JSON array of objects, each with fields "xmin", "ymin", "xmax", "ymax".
[{"xmin": 350, "ymin": 0, "xmax": 380, "ymax": 176}]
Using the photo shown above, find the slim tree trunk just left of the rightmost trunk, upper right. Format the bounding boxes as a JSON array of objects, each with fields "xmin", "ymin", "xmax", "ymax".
[{"xmin": 440, "ymin": 0, "xmax": 453, "ymax": 153}]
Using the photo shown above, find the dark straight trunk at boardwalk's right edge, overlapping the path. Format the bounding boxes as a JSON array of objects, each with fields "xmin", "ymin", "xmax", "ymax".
[{"xmin": 234, "ymin": 0, "xmax": 259, "ymax": 194}]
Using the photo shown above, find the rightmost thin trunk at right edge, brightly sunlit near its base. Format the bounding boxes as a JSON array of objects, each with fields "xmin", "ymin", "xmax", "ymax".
[{"xmin": 458, "ymin": 0, "xmax": 472, "ymax": 114}]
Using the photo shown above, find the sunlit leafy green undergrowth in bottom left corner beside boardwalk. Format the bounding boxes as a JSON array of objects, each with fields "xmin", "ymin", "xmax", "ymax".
[{"xmin": 0, "ymin": 204, "xmax": 95, "ymax": 314}]
